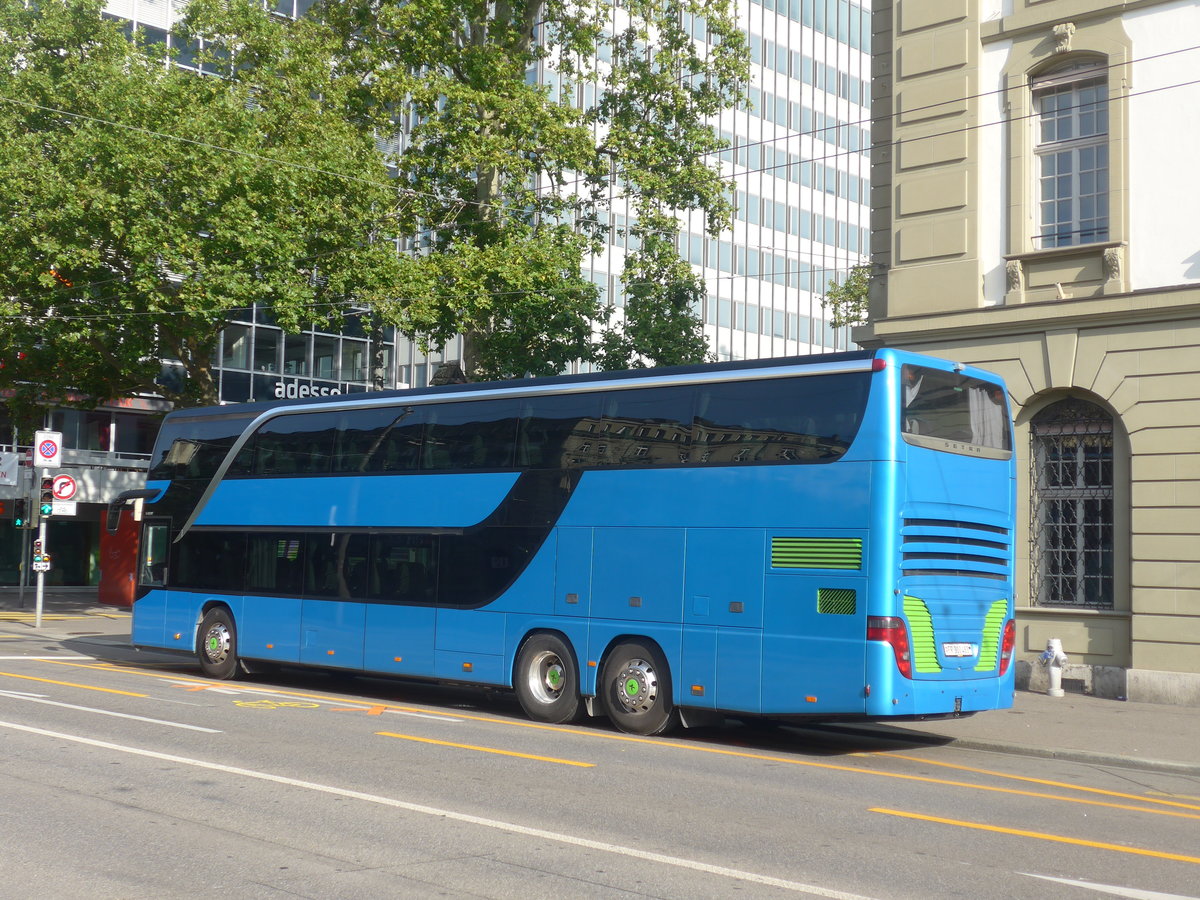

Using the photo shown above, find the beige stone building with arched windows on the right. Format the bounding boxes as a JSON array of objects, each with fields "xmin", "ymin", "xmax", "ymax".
[{"xmin": 854, "ymin": 0, "xmax": 1200, "ymax": 704}]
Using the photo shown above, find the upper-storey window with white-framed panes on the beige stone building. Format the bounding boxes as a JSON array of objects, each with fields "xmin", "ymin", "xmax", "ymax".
[{"xmin": 1032, "ymin": 61, "xmax": 1109, "ymax": 250}]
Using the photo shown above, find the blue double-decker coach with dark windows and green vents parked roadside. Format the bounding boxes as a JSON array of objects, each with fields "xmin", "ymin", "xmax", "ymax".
[{"xmin": 114, "ymin": 349, "xmax": 1015, "ymax": 734}]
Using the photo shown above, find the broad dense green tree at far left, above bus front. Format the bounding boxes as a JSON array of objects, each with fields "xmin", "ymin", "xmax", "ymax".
[{"xmin": 0, "ymin": 0, "xmax": 401, "ymax": 434}]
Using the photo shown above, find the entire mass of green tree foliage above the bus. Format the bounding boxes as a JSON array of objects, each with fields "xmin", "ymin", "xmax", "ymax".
[{"xmin": 0, "ymin": 0, "xmax": 748, "ymax": 434}]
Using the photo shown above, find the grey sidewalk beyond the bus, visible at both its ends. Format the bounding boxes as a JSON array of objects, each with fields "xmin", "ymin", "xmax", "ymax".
[{"xmin": 0, "ymin": 588, "xmax": 1200, "ymax": 775}]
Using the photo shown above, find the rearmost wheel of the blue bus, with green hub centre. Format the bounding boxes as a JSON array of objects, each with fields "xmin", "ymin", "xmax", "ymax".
[{"xmin": 599, "ymin": 641, "xmax": 679, "ymax": 734}]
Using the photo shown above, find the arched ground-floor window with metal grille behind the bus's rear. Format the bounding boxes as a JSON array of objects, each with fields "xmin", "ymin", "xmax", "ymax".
[{"xmin": 1030, "ymin": 400, "xmax": 1114, "ymax": 610}]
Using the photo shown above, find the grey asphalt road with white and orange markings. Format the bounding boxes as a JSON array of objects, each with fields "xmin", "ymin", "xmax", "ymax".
[{"xmin": 0, "ymin": 636, "xmax": 1200, "ymax": 900}]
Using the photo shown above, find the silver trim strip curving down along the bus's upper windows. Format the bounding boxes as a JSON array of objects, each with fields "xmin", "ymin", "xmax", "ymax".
[{"xmin": 174, "ymin": 359, "xmax": 872, "ymax": 544}]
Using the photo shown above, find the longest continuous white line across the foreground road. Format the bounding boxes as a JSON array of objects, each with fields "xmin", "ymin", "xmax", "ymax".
[{"xmin": 0, "ymin": 721, "xmax": 871, "ymax": 900}]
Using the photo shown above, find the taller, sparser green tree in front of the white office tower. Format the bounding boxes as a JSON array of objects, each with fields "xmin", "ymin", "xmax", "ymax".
[{"xmin": 320, "ymin": 0, "xmax": 748, "ymax": 378}]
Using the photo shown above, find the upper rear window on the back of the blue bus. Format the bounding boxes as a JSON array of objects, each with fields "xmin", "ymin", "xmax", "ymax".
[{"xmin": 901, "ymin": 365, "xmax": 1013, "ymax": 454}]
